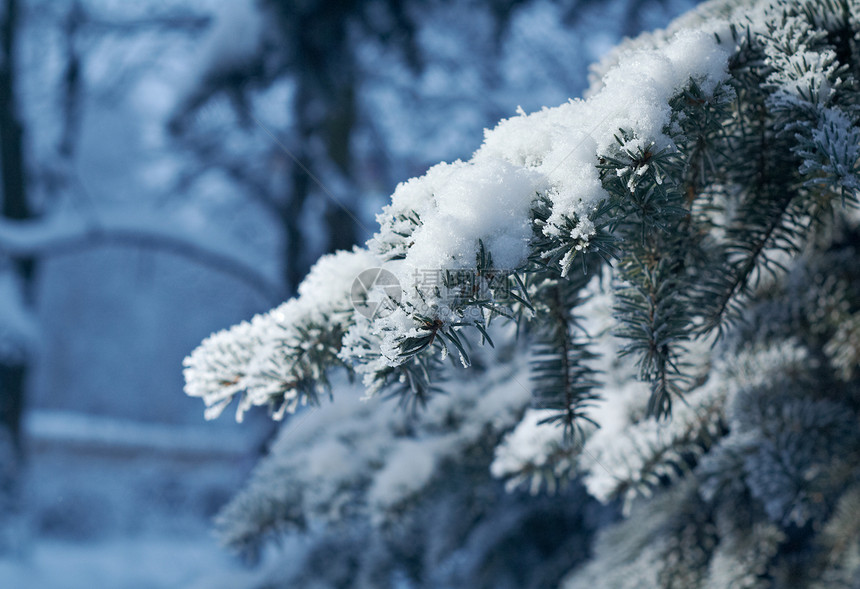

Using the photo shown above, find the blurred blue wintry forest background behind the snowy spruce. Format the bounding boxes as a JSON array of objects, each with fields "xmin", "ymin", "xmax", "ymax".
[{"xmin": 0, "ymin": 0, "xmax": 695, "ymax": 587}]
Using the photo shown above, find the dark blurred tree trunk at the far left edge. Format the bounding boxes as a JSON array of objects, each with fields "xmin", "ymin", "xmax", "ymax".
[{"xmin": 0, "ymin": 0, "xmax": 30, "ymax": 536}]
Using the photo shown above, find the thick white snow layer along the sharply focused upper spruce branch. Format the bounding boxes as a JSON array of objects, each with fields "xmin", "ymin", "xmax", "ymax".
[{"xmin": 185, "ymin": 21, "xmax": 730, "ymax": 418}]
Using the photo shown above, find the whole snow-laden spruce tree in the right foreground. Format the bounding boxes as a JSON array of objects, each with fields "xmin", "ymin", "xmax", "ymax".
[{"xmin": 186, "ymin": 0, "xmax": 860, "ymax": 587}]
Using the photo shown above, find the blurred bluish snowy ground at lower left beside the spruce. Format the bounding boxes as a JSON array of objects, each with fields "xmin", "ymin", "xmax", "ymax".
[{"xmin": 0, "ymin": 410, "xmax": 278, "ymax": 589}]
